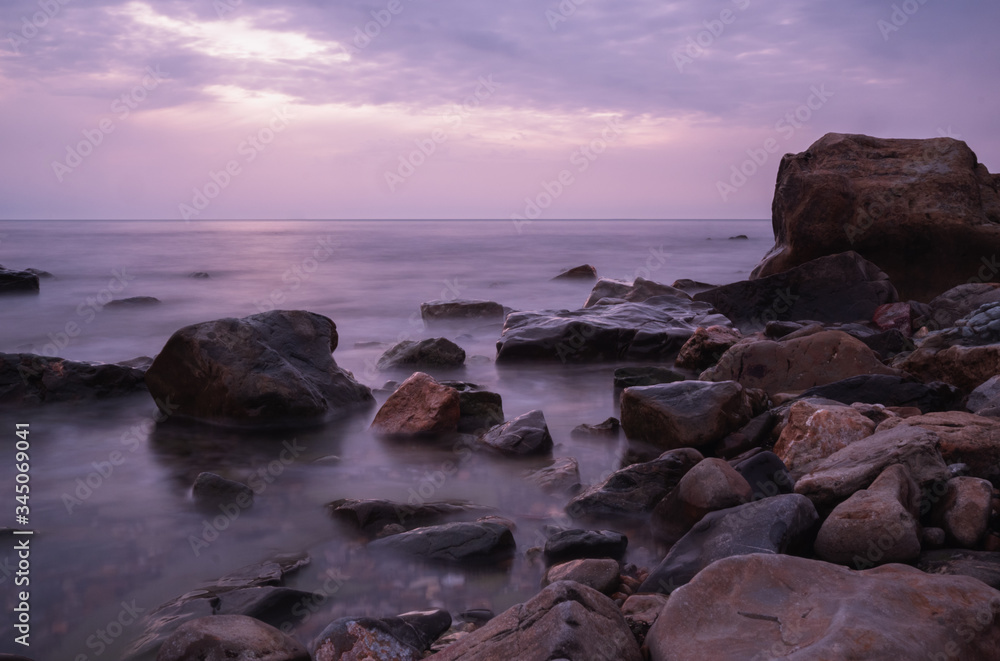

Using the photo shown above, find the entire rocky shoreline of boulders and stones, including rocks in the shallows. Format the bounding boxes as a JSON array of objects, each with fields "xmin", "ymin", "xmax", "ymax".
[{"xmin": 0, "ymin": 134, "xmax": 1000, "ymax": 661}]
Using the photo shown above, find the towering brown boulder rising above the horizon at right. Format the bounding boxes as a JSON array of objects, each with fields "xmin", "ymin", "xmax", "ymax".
[{"xmin": 751, "ymin": 133, "xmax": 1000, "ymax": 301}]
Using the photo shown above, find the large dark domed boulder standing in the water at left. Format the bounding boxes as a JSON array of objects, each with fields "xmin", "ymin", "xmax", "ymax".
[{"xmin": 146, "ymin": 310, "xmax": 374, "ymax": 424}]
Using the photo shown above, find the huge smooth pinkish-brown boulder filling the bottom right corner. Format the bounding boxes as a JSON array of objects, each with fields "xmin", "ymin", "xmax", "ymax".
[{"xmin": 646, "ymin": 554, "xmax": 1000, "ymax": 661}]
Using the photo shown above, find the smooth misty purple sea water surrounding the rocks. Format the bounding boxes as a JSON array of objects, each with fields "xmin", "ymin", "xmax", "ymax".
[{"xmin": 0, "ymin": 221, "xmax": 772, "ymax": 661}]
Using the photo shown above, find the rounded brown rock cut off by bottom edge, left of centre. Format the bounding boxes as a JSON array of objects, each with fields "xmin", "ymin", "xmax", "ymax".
[{"xmin": 156, "ymin": 615, "xmax": 311, "ymax": 661}]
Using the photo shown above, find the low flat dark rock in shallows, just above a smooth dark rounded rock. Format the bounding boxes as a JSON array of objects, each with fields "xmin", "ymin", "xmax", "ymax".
[{"xmin": 326, "ymin": 493, "xmax": 494, "ymax": 537}]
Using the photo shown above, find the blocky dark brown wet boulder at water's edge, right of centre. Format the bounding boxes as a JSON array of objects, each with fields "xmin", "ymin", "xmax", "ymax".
[{"xmin": 621, "ymin": 381, "xmax": 759, "ymax": 449}]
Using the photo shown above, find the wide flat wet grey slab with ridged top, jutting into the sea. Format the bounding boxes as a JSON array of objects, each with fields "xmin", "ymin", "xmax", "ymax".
[{"xmin": 497, "ymin": 295, "xmax": 730, "ymax": 363}]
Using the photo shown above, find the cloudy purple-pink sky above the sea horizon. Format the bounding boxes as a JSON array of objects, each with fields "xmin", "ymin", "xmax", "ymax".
[{"xmin": 0, "ymin": 0, "xmax": 1000, "ymax": 219}]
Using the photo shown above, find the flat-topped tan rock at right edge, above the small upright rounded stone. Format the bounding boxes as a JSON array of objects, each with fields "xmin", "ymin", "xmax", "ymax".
[{"xmin": 876, "ymin": 411, "xmax": 1000, "ymax": 480}]
